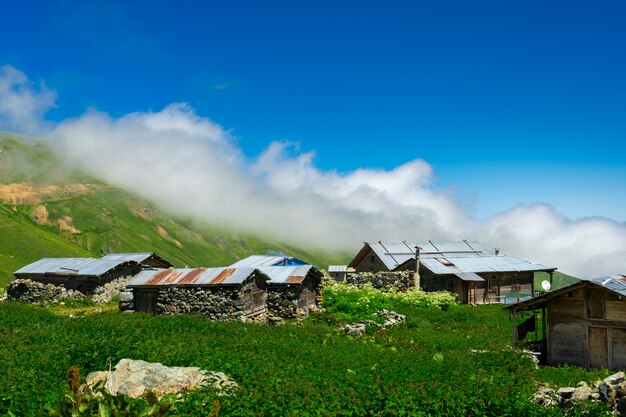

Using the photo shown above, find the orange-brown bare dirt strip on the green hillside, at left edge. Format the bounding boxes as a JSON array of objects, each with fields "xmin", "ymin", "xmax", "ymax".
[{"xmin": 0, "ymin": 183, "xmax": 102, "ymax": 205}]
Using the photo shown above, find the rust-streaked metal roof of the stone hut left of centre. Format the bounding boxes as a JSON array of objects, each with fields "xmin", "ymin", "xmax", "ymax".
[{"xmin": 127, "ymin": 268, "xmax": 255, "ymax": 287}]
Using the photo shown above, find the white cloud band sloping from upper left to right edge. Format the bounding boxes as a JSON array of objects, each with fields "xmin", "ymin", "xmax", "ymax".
[{"xmin": 0, "ymin": 66, "xmax": 626, "ymax": 276}]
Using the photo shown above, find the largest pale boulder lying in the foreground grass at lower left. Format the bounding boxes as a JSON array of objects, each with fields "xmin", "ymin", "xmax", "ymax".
[{"xmin": 85, "ymin": 359, "xmax": 238, "ymax": 398}]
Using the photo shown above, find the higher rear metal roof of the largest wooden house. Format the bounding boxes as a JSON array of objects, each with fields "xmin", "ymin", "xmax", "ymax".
[{"xmin": 365, "ymin": 241, "xmax": 491, "ymax": 270}]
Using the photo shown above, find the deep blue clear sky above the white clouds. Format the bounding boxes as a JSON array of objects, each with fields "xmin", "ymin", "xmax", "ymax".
[{"xmin": 0, "ymin": 1, "xmax": 626, "ymax": 222}]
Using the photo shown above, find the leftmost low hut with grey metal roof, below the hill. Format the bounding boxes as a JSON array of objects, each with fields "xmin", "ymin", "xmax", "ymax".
[{"xmin": 13, "ymin": 258, "xmax": 142, "ymax": 294}]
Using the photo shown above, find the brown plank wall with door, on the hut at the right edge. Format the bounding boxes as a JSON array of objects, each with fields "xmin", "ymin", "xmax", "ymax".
[{"xmin": 547, "ymin": 287, "xmax": 626, "ymax": 369}]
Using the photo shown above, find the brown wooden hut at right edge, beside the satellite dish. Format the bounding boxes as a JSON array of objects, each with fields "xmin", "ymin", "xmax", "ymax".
[{"xmin": 506, "ymin": 275, "xmax": 626, "ymax": 370}]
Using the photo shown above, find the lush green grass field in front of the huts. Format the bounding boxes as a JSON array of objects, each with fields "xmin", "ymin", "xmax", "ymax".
[{"xmin": 0, "ymin": 284, "xmax": 608, "ymax": 416}]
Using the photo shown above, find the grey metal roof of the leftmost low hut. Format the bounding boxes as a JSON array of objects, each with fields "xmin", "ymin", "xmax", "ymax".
[{"xmin": 14, "ymin": 258, "xmax": 134, "ymax": 276}]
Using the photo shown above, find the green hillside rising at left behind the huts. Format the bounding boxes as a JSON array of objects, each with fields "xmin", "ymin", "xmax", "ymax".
[{"xmin": 0, "ymin": 134, "xmax": 346, "ymax": 287}]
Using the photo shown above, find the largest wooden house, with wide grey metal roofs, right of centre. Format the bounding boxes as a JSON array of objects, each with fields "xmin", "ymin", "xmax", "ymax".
[{"xmin": 348, "ymin": 240, "xmax": 556, "ymax": 304}]
